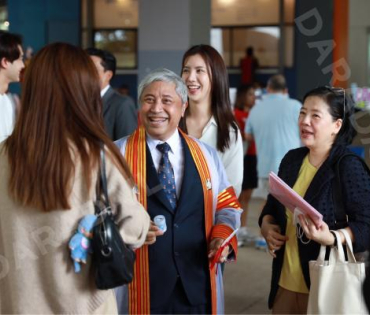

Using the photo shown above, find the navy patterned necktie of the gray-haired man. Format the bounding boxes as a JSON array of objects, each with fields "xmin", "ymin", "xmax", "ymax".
[{"xmin": 157, "ymin": 142, "xmax": 177, "ymax": 209}]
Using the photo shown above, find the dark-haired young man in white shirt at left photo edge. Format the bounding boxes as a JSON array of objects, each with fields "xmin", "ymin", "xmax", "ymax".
[{"xmin": 0, "ymin": 31, "xmax": 24, "ymax": 142}]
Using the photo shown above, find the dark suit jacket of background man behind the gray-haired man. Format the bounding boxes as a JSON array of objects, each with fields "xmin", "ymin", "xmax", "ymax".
[{"xmin": 102, "ymin": 87, "xmax": 137, "ymax": 141}]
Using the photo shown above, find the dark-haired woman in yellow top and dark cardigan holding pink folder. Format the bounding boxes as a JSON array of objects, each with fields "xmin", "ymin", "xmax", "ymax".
[{"xmin": 259, "ymin": 87, "xmax": 370, "ymax": 314}]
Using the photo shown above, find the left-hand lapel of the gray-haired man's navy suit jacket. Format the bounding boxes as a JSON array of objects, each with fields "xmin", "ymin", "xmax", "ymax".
[{"xmin": 146, "ymin": 145, "xmax": 174, "ymax": 214}]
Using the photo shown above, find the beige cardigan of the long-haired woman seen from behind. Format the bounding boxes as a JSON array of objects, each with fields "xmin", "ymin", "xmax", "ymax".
[{"xmin": 0, "ymin": 144, "xmax": 149, "ymax": 314}]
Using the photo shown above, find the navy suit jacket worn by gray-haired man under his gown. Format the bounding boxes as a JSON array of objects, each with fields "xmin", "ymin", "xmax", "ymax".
[{"xmin": 147, "ymin": 138, "xmax": 210, "ymax": 308}]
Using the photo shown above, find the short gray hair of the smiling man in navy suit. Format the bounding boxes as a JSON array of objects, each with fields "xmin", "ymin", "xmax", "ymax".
[{"xmin": 137, "ymin": 68, "xmax": 188, "ymax": 104}]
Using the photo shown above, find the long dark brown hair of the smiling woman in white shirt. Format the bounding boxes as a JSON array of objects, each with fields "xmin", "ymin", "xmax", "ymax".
[{"xmin": 180, "ymin": 45, "xmax": 238, "ymax": 152}]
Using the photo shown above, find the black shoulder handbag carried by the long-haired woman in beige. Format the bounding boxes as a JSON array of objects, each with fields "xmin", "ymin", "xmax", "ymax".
[{"xmin": 92, "ymin": 146, "xmax": 135, "ymax": 290}]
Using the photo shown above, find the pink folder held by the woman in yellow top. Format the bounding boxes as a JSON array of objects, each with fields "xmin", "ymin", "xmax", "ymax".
[{"xmin": 269, "ymin": 172, "xmax": 322, "ymax": 228}]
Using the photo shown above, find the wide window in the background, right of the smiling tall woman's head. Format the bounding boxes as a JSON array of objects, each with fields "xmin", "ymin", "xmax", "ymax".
[{"xmin": 211, "ymin": 0, "xmax": 295, "ymax": 68}]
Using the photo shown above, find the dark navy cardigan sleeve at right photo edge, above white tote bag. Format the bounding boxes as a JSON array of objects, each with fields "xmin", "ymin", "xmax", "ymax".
[{"xmin": 340, "ymin": 156, "xmax": 370, "ymax": 252}]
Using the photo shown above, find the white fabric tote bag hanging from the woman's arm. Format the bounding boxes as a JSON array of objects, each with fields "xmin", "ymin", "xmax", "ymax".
[{"xmin": 307, "ymin": 229, "xmax": 368, "ymax": 314}]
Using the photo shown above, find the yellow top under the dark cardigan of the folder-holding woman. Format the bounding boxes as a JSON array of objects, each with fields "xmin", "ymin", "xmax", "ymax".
[{"xmin": 279, "ymin": 155, "xmax": 317, "ymax": 293}]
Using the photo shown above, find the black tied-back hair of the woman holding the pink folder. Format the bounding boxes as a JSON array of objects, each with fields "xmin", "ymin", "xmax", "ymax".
[{"xmin": 303, "ymin": 86, "xmax": 357, "ymax": 145}]
